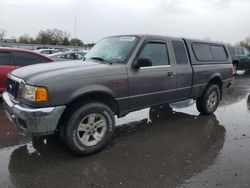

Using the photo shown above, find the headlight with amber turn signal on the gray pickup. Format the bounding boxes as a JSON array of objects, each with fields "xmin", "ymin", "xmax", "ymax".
[{"xmin": 22, "ymin": 85, "xmax": 49, "ymax": 102}]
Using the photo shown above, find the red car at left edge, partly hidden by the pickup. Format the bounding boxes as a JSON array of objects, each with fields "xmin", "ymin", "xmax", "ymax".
[{"xmin": 0, "ymin": 47, "xmax": 54, "ymax": 96}]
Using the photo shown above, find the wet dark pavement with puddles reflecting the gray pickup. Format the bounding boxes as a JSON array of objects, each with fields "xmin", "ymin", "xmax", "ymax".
[{"xmin": 0, "ymin": 75, "xmax": 250, "ymax": 188}]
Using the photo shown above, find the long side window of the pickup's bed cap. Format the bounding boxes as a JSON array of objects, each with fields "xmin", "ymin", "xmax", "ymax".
[{"xmin": 192, "ymin": 43, "xmax": 228, "ymax": 62}]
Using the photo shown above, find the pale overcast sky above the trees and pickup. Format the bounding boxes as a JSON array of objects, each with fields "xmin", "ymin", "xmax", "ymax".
[{"xmin": 0, "ymin": 0, "xmax": 250, "ymax": 44}]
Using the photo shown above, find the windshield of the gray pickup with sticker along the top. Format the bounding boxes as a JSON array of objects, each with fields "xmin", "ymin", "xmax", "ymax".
[{"xmin": 85, "ymin": 36, "xmax": 138, "ymax": 64}]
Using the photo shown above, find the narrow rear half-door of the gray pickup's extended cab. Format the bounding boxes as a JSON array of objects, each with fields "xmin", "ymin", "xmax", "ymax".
[{"xmin": 171, "ymin": 40, "xmax": 193, "ymax": 100}]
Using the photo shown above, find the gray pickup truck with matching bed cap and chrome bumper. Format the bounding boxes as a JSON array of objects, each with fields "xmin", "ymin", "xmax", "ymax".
[{"xmin": 3, "ymin": 35, "xmax": 233, "ymax": 155}]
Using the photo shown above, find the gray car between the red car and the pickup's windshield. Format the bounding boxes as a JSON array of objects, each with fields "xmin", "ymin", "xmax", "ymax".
[{"xmin": 49, "ymin": 51, "xmax": 86, "ymax": 61}]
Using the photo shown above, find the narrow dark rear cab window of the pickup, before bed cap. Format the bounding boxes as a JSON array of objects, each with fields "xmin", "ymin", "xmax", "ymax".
[{"xmin": 172, "ymin": 41, "xmax": 188, "ymax": 64}]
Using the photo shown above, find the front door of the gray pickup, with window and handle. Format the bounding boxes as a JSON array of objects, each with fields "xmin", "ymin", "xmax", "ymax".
[{"xmin": 128, "ymin": 40, "xmax": 176, "ymax": 109}]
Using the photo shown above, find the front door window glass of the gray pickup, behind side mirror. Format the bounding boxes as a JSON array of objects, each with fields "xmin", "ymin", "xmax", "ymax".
[{"xmin": 139, "ymin": 42, "xmax": 169, "ymax": 66}]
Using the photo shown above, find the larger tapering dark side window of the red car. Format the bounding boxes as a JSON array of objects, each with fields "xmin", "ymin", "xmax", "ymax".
[{"xmin": 14, "ymin": 52, "xmax": 49, "ymax": 66}]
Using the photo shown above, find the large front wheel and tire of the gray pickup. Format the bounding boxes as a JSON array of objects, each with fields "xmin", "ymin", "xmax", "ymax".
[{"xmin": 64, "ymin": 102, "xmax": 115, "ymax": 155}]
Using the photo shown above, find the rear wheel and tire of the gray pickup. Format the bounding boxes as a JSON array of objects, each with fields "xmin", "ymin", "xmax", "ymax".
[{"xmin": 196, "ymin": 84, "xmax": 221, "ymax": 115}]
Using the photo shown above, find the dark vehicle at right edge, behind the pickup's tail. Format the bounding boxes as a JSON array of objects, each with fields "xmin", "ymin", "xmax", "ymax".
[{"xmin": 228, "ymin": 47, "xmax": 250, "ymax": 71}]
